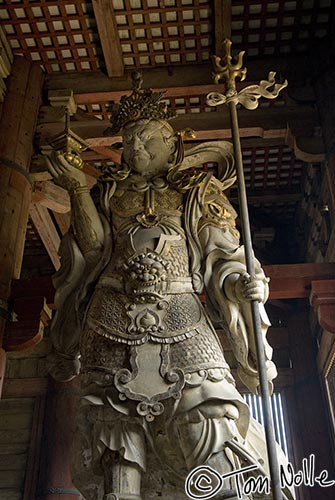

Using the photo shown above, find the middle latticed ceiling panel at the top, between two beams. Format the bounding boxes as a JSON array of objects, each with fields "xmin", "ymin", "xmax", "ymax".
[{"xmin": 112, "ymin": 0, "xmax": 213, "ymax": 69}]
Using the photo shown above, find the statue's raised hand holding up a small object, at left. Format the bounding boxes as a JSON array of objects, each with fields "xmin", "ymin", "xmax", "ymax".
[{"xmin": 45, "ymin": 151, "xmax": 86, "ymax": 193}]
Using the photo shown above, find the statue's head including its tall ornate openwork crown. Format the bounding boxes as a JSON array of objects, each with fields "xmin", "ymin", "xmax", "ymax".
[{"xmin": 105, "ymin": 72, "xmax": 181, "ymax": 177}]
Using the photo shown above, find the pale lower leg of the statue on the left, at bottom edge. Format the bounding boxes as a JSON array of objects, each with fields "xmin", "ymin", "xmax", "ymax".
[{"xmin": 101, "ymin": 450, "xmax": 141, "ymax": 500}]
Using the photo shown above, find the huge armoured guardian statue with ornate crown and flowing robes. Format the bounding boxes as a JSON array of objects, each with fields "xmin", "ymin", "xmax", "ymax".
[{"xmin": 47, "ymin": 75, "xmax": 293, "ymax": 500}]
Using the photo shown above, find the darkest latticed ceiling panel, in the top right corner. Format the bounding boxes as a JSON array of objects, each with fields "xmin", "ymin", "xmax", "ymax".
[{"xmin": 231, "ymin": 0, "xmax": 333, "ymax": 57}]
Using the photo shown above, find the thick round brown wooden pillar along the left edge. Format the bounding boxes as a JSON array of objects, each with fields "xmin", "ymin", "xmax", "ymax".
[{"xmin": 0, "ymin": 56, "xmax": 43, "ymax": 394}]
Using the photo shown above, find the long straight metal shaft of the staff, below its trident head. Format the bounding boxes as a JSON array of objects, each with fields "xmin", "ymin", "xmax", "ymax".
[{"xmin": 228, "ymin": 101, "xmax": 283, "ymax": 500}]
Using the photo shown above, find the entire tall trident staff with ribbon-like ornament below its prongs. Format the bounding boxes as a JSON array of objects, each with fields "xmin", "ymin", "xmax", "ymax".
[{"xmin": 207, "ymin": 39, "xmax": 287, "ymax": 500}]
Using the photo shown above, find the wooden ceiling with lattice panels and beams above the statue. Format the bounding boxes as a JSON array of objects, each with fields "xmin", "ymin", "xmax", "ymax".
[{"xmin": 0, "ymin": 0, "xmax": 334, "ymax": 274}]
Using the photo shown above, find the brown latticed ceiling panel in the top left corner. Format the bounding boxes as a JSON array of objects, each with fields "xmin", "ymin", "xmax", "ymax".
[{"xmin": 0, "ymin": 0, "xmax": 100, "ymax": 73}]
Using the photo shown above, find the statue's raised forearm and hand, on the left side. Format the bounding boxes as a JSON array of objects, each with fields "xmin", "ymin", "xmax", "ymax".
[{"xmin": 46, "ymin": 152, "xmax": 104, "ymax": 256}]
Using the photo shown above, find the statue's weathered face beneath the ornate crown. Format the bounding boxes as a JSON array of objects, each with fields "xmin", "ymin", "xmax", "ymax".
[{"xmin": 123, "ymin": 120, "xmax": 176, "ymax": 177}]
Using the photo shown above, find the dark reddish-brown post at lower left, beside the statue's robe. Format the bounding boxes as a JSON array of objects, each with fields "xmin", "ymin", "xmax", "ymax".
[{"xmin": 34, "ymin": 378, "xmax": 82, "ymax": 500}]
